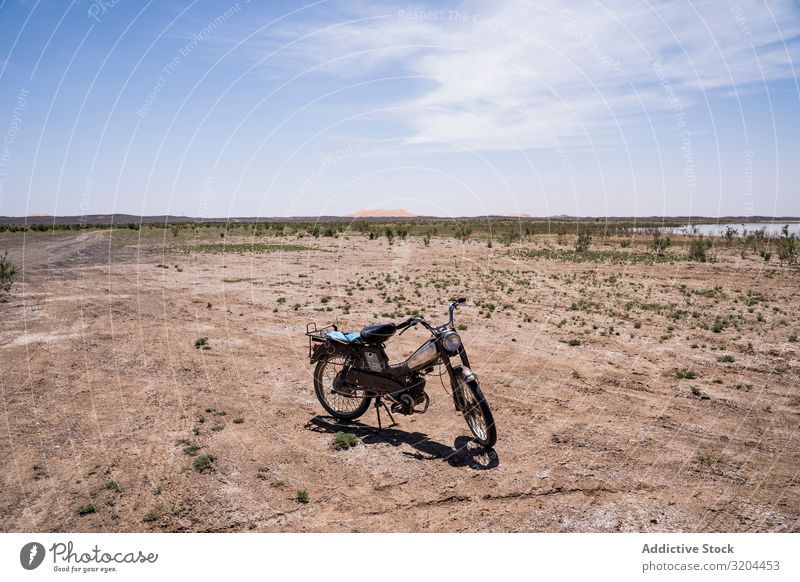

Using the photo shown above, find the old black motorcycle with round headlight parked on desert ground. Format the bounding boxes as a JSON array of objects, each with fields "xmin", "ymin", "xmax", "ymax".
[{"xmin": 306, "ymin": 297, "xmax": 497, "ymax": 448}]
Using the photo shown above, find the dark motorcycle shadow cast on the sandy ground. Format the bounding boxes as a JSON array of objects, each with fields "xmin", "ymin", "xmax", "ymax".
[{"xmin": 304, "ymin": 416, "xmax": 500, "ymax": 471}]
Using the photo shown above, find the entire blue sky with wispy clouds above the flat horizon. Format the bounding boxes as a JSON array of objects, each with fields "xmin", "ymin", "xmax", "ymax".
[{"xmin": 0, "ymin": 0, "xmax": 800, "ymax": 217}]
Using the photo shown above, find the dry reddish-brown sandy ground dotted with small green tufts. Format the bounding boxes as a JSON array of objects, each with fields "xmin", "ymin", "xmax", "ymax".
[{"xmin": 0, "ymin": 231, "xmax": 800, "ymax": 532}]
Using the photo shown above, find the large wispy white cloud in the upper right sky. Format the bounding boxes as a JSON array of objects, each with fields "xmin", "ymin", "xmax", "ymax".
[{"xmin": 256, "ymin": 0, "xmax": 800, "ymax": 150}]
